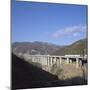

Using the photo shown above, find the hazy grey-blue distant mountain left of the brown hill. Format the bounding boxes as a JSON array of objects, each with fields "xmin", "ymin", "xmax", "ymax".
[{"xmin": 12, "ymin": 41, "xmax": 60, "ymax": 54}]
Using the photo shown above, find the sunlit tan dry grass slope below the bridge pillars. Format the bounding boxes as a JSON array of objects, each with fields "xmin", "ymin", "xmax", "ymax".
[{"xmin": 50, "ymin": 64, "xmax": 87, "ymax": 80}]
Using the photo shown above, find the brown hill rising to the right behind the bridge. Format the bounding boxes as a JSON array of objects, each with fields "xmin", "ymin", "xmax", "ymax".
[{"xmin": 52, "ymin": 39, "xmax": 87, "ymax": 55}]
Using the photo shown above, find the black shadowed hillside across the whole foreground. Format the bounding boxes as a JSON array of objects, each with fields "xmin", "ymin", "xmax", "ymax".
[{"xmin": 11, "ymin": 54, "xmax": 87, "ymax": 90}]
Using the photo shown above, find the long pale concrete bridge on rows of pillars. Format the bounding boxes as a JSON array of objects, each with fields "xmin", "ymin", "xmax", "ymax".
[{"xmin": 24, "ymin": 54, "xmax": 87, "ymax": 68}]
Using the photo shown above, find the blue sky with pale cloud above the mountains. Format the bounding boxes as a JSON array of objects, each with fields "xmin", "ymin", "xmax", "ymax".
[{"xmin": 11, "ymin": 0, "xmax": 87, "ymax": 45}]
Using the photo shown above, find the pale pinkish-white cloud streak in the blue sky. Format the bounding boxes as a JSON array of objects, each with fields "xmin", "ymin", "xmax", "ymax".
[{"xmin": 52, "ymin": 25, "xmax": 86, "ymax": 38}]
